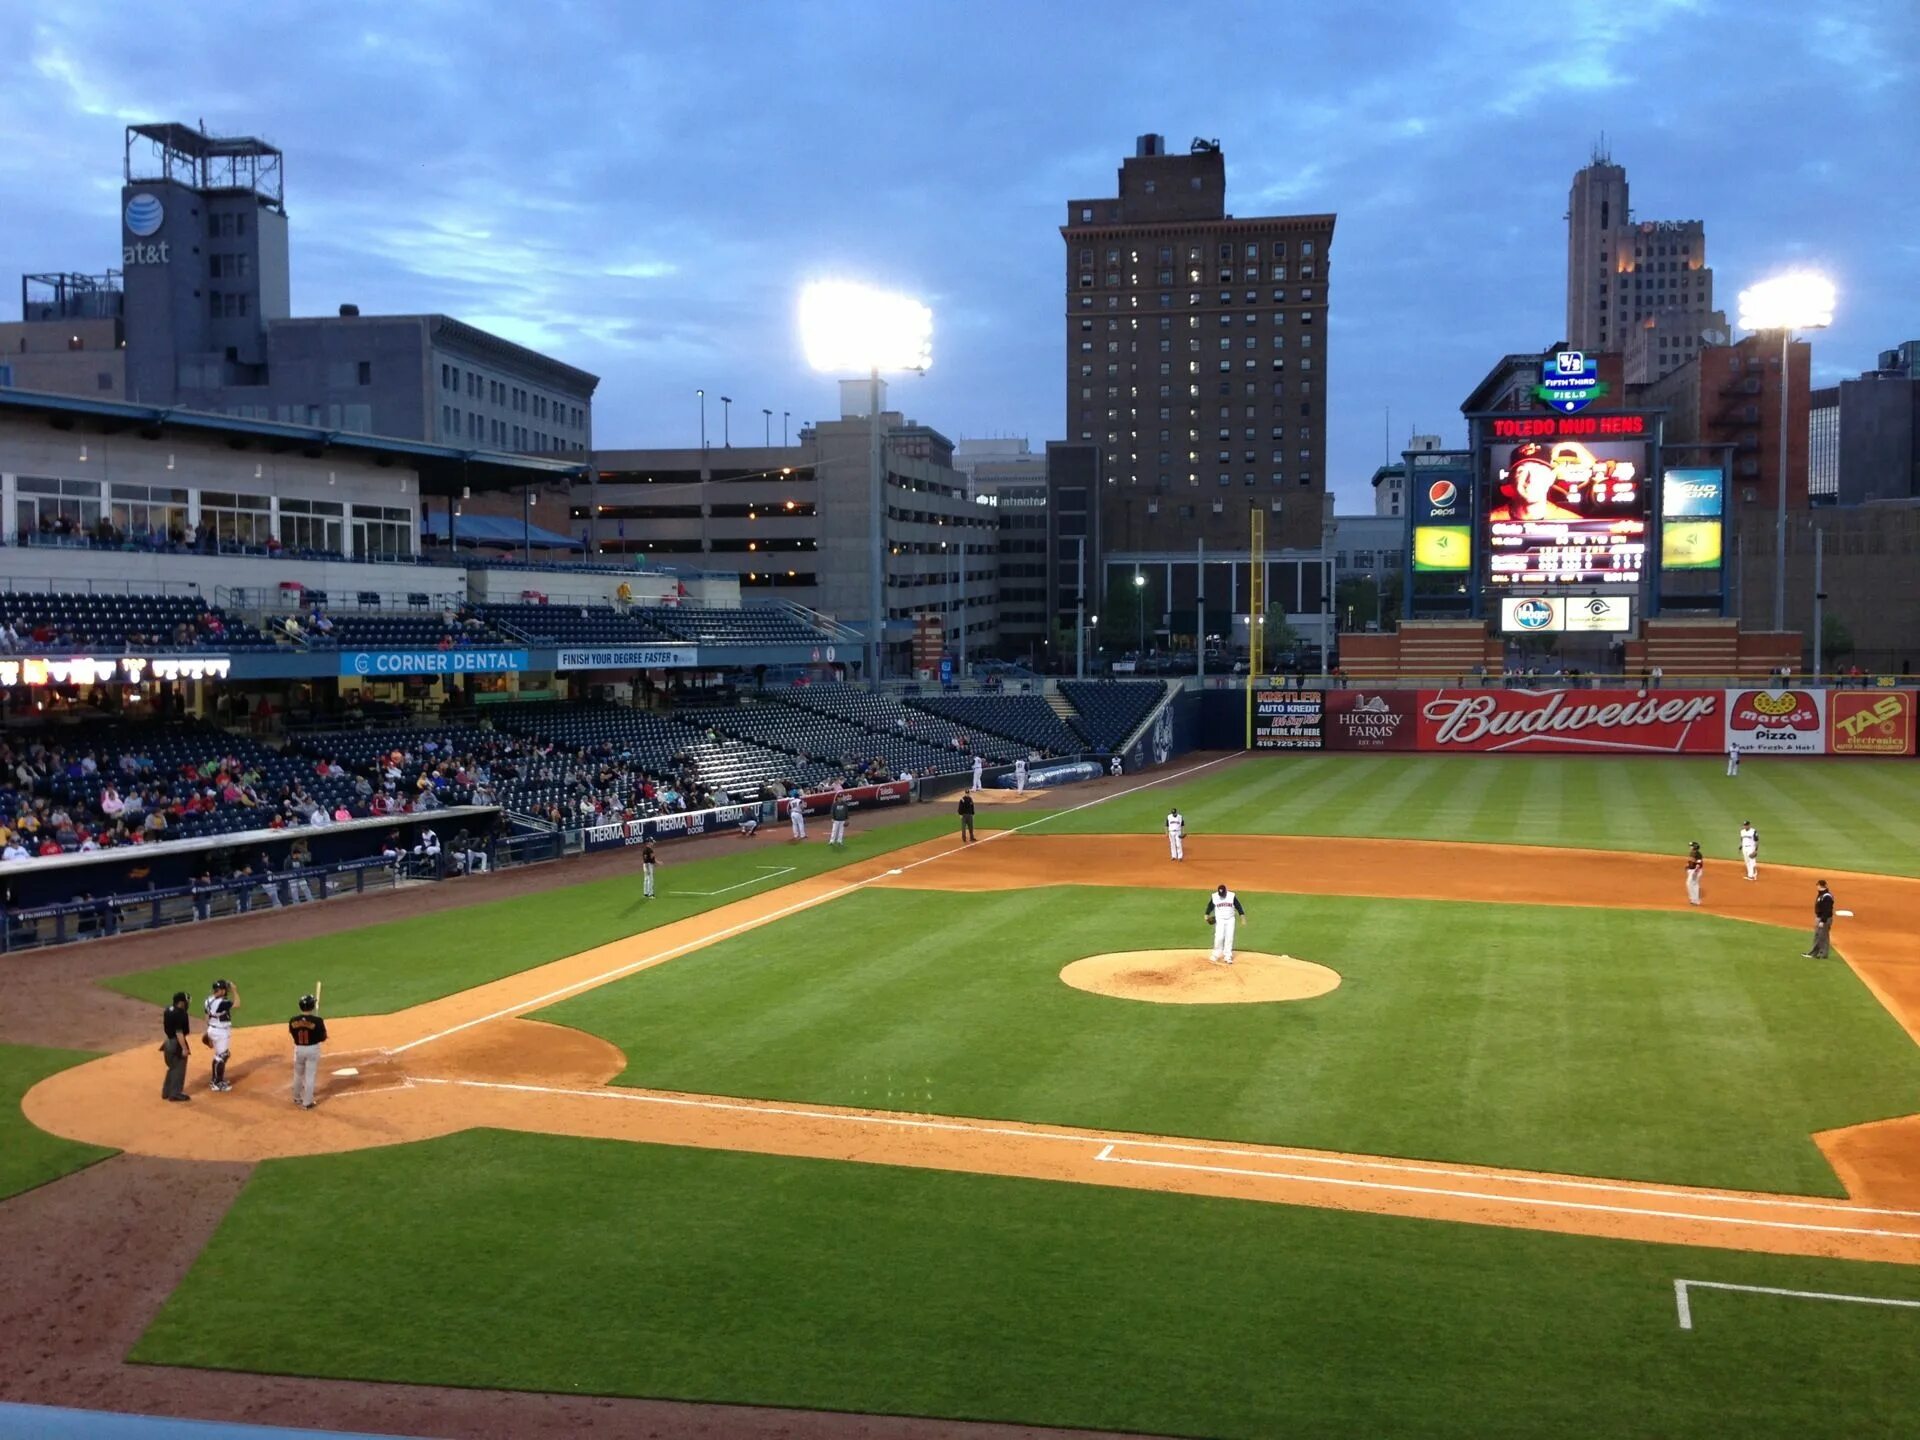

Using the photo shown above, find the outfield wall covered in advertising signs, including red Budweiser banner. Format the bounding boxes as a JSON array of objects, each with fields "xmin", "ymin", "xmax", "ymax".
[{"xmin": 1204, "ymin": 685, "xmax": 1916, "ymax": 758}]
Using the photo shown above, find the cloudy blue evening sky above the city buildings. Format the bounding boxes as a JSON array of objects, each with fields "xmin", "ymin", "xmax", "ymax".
[{"xmin": 0, "ymin": 0, "xmax": 1920, "ymax": 511}]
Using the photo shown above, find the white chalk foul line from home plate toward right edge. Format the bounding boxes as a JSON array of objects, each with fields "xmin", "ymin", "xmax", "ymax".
[{"xmin": 415, "ymin": 1075, "xmax": 1920, "ymax": 1240}]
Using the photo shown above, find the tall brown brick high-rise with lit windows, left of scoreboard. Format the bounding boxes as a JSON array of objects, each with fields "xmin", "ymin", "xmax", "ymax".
[{"xmin": 1060, "ymin": 134, "xmax": 1334, "ymax": 568}]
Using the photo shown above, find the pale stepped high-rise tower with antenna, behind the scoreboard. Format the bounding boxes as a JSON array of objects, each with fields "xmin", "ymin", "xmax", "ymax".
[{"xmin": 1567, "ymin": 150, "xmax": 1730, "ymax": 384}]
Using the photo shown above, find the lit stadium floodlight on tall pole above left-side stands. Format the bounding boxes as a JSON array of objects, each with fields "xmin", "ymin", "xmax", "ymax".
[{"xmin": 801, "ymin": 280, "xmax": 933, "ymax": 682}]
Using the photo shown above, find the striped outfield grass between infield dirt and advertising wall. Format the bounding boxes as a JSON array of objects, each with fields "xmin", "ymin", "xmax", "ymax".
[{"xmin": 1041, "ymin": 755, "xmax": 1920, "ymax": 876}]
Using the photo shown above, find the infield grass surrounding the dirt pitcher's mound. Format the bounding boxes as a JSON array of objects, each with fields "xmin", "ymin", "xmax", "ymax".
[{"xmin": 536, "ymin": 887, "xmax": 1920, "ymax": 1194}]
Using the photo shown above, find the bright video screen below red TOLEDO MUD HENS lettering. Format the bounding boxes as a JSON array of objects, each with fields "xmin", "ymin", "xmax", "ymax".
[{"xmin": 1486, "ymin": 440, "xmax": 1653, "ymax": 586}]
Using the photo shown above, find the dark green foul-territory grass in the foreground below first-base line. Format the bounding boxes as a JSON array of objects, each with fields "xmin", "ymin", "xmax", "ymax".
[{"xmin": 132, "ymin": 1131, "xmax": 1920, "ymax": 1440}]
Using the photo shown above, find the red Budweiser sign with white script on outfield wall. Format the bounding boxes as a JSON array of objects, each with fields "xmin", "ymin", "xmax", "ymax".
[{"xmin": 1419, "ymin": 689, "xmax": 1726, "ymax": 755}]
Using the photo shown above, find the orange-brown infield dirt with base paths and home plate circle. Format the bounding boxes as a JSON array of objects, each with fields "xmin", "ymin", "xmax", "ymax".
[{"xmin": 23, "ymin": 831, "xmax": 1920, "ymax": 1263}]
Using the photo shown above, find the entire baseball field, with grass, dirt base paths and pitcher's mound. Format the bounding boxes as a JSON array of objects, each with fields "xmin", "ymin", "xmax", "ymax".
[{"xmin": 11, "ymin": 756, "xmax": 1920, "ymax": 1436}]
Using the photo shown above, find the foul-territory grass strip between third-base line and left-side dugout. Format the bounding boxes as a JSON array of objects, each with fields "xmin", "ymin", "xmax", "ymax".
[{"xmin": 106, "ymin": 814, "xmax": 952, "ymax": 1023}]
